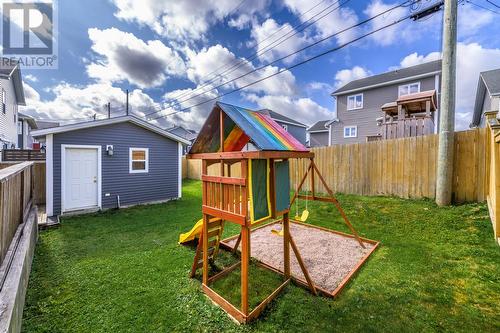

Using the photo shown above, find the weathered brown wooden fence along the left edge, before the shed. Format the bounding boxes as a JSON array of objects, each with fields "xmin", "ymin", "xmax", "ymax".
[{"xmin": 0, "ymin": 162, "xmax": 34, "ymax": 264}]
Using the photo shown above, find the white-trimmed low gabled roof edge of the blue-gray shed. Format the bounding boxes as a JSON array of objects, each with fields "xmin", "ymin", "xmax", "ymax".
[{"xmin": 31, "ymin": 116, "xmax": 190, "ymax": 145}]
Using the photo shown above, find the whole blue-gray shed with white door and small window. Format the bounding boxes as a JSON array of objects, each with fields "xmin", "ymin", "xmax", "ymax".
[{"xmin": 32, "ymin": 116, "xmax": 190, "ymax": 216}]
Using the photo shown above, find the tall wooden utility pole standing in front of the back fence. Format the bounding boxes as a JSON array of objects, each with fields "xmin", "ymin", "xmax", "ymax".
[{"xmin": 436, "ymin": 0, "xmax": 457, "ymax": 206}]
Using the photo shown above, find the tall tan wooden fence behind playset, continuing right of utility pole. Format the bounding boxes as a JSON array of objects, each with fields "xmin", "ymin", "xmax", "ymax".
[{"xmin": 185, "ymin": 128, "xmax": 489, "ymax": 203}]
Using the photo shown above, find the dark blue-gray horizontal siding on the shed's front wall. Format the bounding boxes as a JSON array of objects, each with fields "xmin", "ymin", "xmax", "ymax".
[{"xmin": 53, "ymin": 123, "xmax": 179, "ymax": 215}]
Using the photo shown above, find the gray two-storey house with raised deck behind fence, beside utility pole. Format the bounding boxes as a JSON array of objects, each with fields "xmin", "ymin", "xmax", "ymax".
[{"xmin": 326, "ymin": 60, "xmax": 441, "ymax": 144}]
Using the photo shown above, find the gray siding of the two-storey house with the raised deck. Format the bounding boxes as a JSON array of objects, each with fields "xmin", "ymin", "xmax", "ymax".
[{"xmin": 331, "ymin": 75, "xmax": 439, "ymax": 144}]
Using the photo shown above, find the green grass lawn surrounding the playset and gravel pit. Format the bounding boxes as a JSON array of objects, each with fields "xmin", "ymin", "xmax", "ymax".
[{"xmin": 23, "ymin": 181, "xmax": 500, "ymax": 332}]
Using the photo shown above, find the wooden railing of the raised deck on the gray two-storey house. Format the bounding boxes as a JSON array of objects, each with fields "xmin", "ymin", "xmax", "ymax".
[{"xmin": 380, "ymin": 116, "xmax": 434, "ymax": 140}]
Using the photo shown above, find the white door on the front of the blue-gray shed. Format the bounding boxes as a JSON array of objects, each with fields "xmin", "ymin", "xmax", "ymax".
[{"xmin": 63, "ymin": 148, "xmax": 98, "ymax": 211}]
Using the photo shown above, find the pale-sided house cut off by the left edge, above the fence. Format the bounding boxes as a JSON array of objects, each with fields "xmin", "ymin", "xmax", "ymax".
[{"xmin": 0, "ymin": 58, "xmax": 26, "ymax": 149}]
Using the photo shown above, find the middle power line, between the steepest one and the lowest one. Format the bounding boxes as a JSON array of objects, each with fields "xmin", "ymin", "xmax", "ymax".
[{"xmin": 144, "ymin": 0, "xmax": 412, "ymax": 117}]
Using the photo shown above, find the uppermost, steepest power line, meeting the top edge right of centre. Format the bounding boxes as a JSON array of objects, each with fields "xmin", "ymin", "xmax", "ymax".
[{"xmin": 170, "ymin": 0, "xmax": 351, "ymax": 102}]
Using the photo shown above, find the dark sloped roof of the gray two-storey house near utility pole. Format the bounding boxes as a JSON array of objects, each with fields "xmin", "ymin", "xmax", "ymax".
[{"xmin": 332, "ymin": 60, "xmax": 441, "ymax": 96}]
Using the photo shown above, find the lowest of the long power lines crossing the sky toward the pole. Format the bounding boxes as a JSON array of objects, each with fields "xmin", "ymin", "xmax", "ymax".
[{"xmin": 151, "ymin": 4, "xmax": 418, "ymax": 120}]
